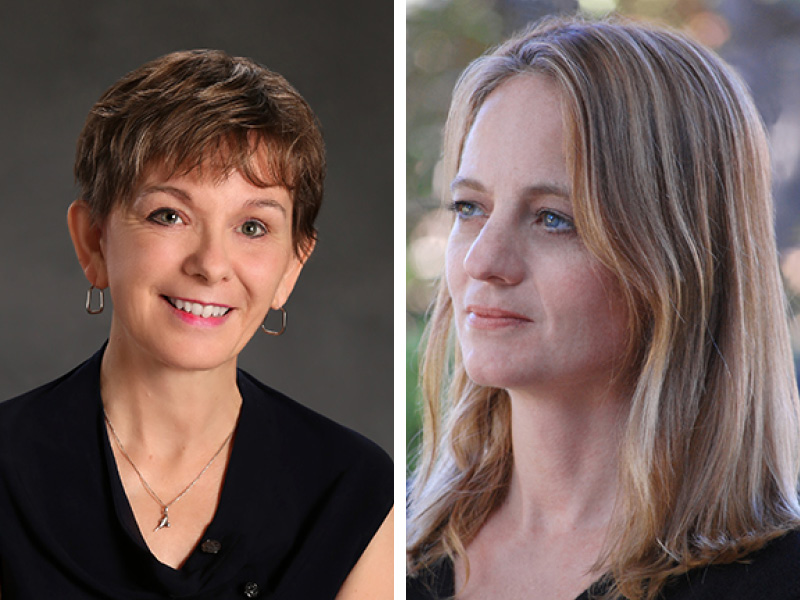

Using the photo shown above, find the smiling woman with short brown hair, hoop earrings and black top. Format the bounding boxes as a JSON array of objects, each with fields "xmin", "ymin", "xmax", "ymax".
[{"xmin": 0, "ymin": 50, "xmax": 392, "ymax": 600}]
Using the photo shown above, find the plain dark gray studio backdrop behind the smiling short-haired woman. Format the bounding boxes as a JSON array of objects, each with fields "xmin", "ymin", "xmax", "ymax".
[{"xmin": 0, "ymin": 0, "xmax": 393, "ymax": 452}]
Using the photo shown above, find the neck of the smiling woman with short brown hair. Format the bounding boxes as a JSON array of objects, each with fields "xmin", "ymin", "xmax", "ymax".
[{"xmin": 100, "ymin": 338, "xmax": 241, "ymax": 454}]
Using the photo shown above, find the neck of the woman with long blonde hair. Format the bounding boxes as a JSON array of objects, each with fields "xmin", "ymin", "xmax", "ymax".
[{"xmin": 504, "ymin": 390, "xmax": 627, "ymax": 535}]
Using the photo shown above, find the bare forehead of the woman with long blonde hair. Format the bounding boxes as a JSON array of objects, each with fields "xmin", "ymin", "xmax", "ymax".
[{"xmin": 458, "ymin": 74, "xmax": 567, "ymax": 188}]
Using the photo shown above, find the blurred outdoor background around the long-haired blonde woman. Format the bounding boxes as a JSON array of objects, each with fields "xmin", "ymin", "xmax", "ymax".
[{"xmin": 406, "ymin": 0, "xmax": 800, "ymax": 468}]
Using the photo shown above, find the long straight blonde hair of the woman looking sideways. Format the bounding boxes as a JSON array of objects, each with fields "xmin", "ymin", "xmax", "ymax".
[{"xmin": 407, "ymin": 19, "xmax": 800, "ymax": 599}]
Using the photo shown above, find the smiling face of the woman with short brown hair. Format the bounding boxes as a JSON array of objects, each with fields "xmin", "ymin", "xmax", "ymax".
[{"xmin": 94, "ymin": 162, "xmax": 302, "ymax": 370}]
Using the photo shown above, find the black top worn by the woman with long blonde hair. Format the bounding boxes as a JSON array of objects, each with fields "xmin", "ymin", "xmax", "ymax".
[{"xmin": 406, "ymin": 531, "xmax": 800, "ymax": 600}]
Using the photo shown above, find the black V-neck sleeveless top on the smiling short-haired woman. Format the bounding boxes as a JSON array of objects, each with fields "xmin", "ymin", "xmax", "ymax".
[{"xmin": 0, "ymin": 350, "xmax": 393, "ymax": 600}]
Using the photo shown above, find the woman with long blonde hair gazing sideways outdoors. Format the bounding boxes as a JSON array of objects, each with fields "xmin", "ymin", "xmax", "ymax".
[{"xmin": 407, "ymin": 14, "xmax": 800, "ymax": 600}]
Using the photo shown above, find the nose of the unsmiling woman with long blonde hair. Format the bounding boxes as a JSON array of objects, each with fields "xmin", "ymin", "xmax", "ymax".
[{"xmin": 464, "ymin": 215, "xmax": 525, "ymax": 285}]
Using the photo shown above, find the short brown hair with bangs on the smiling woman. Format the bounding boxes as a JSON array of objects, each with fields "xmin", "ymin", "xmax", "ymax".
[{"xmin": 75, "ymin": 50, "xmax": 325, "ymax": 255}]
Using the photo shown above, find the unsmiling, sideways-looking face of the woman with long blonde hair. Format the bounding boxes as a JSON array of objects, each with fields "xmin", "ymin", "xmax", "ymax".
[{"xmin": 446, "ymin": 75, "xmax": 626, "ymax": 394}]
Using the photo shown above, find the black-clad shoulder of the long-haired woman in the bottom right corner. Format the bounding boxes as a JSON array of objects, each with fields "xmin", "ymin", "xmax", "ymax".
[{"xmin": 662, "ymin": 530, "xmax": 800, "ymax": 600}]
